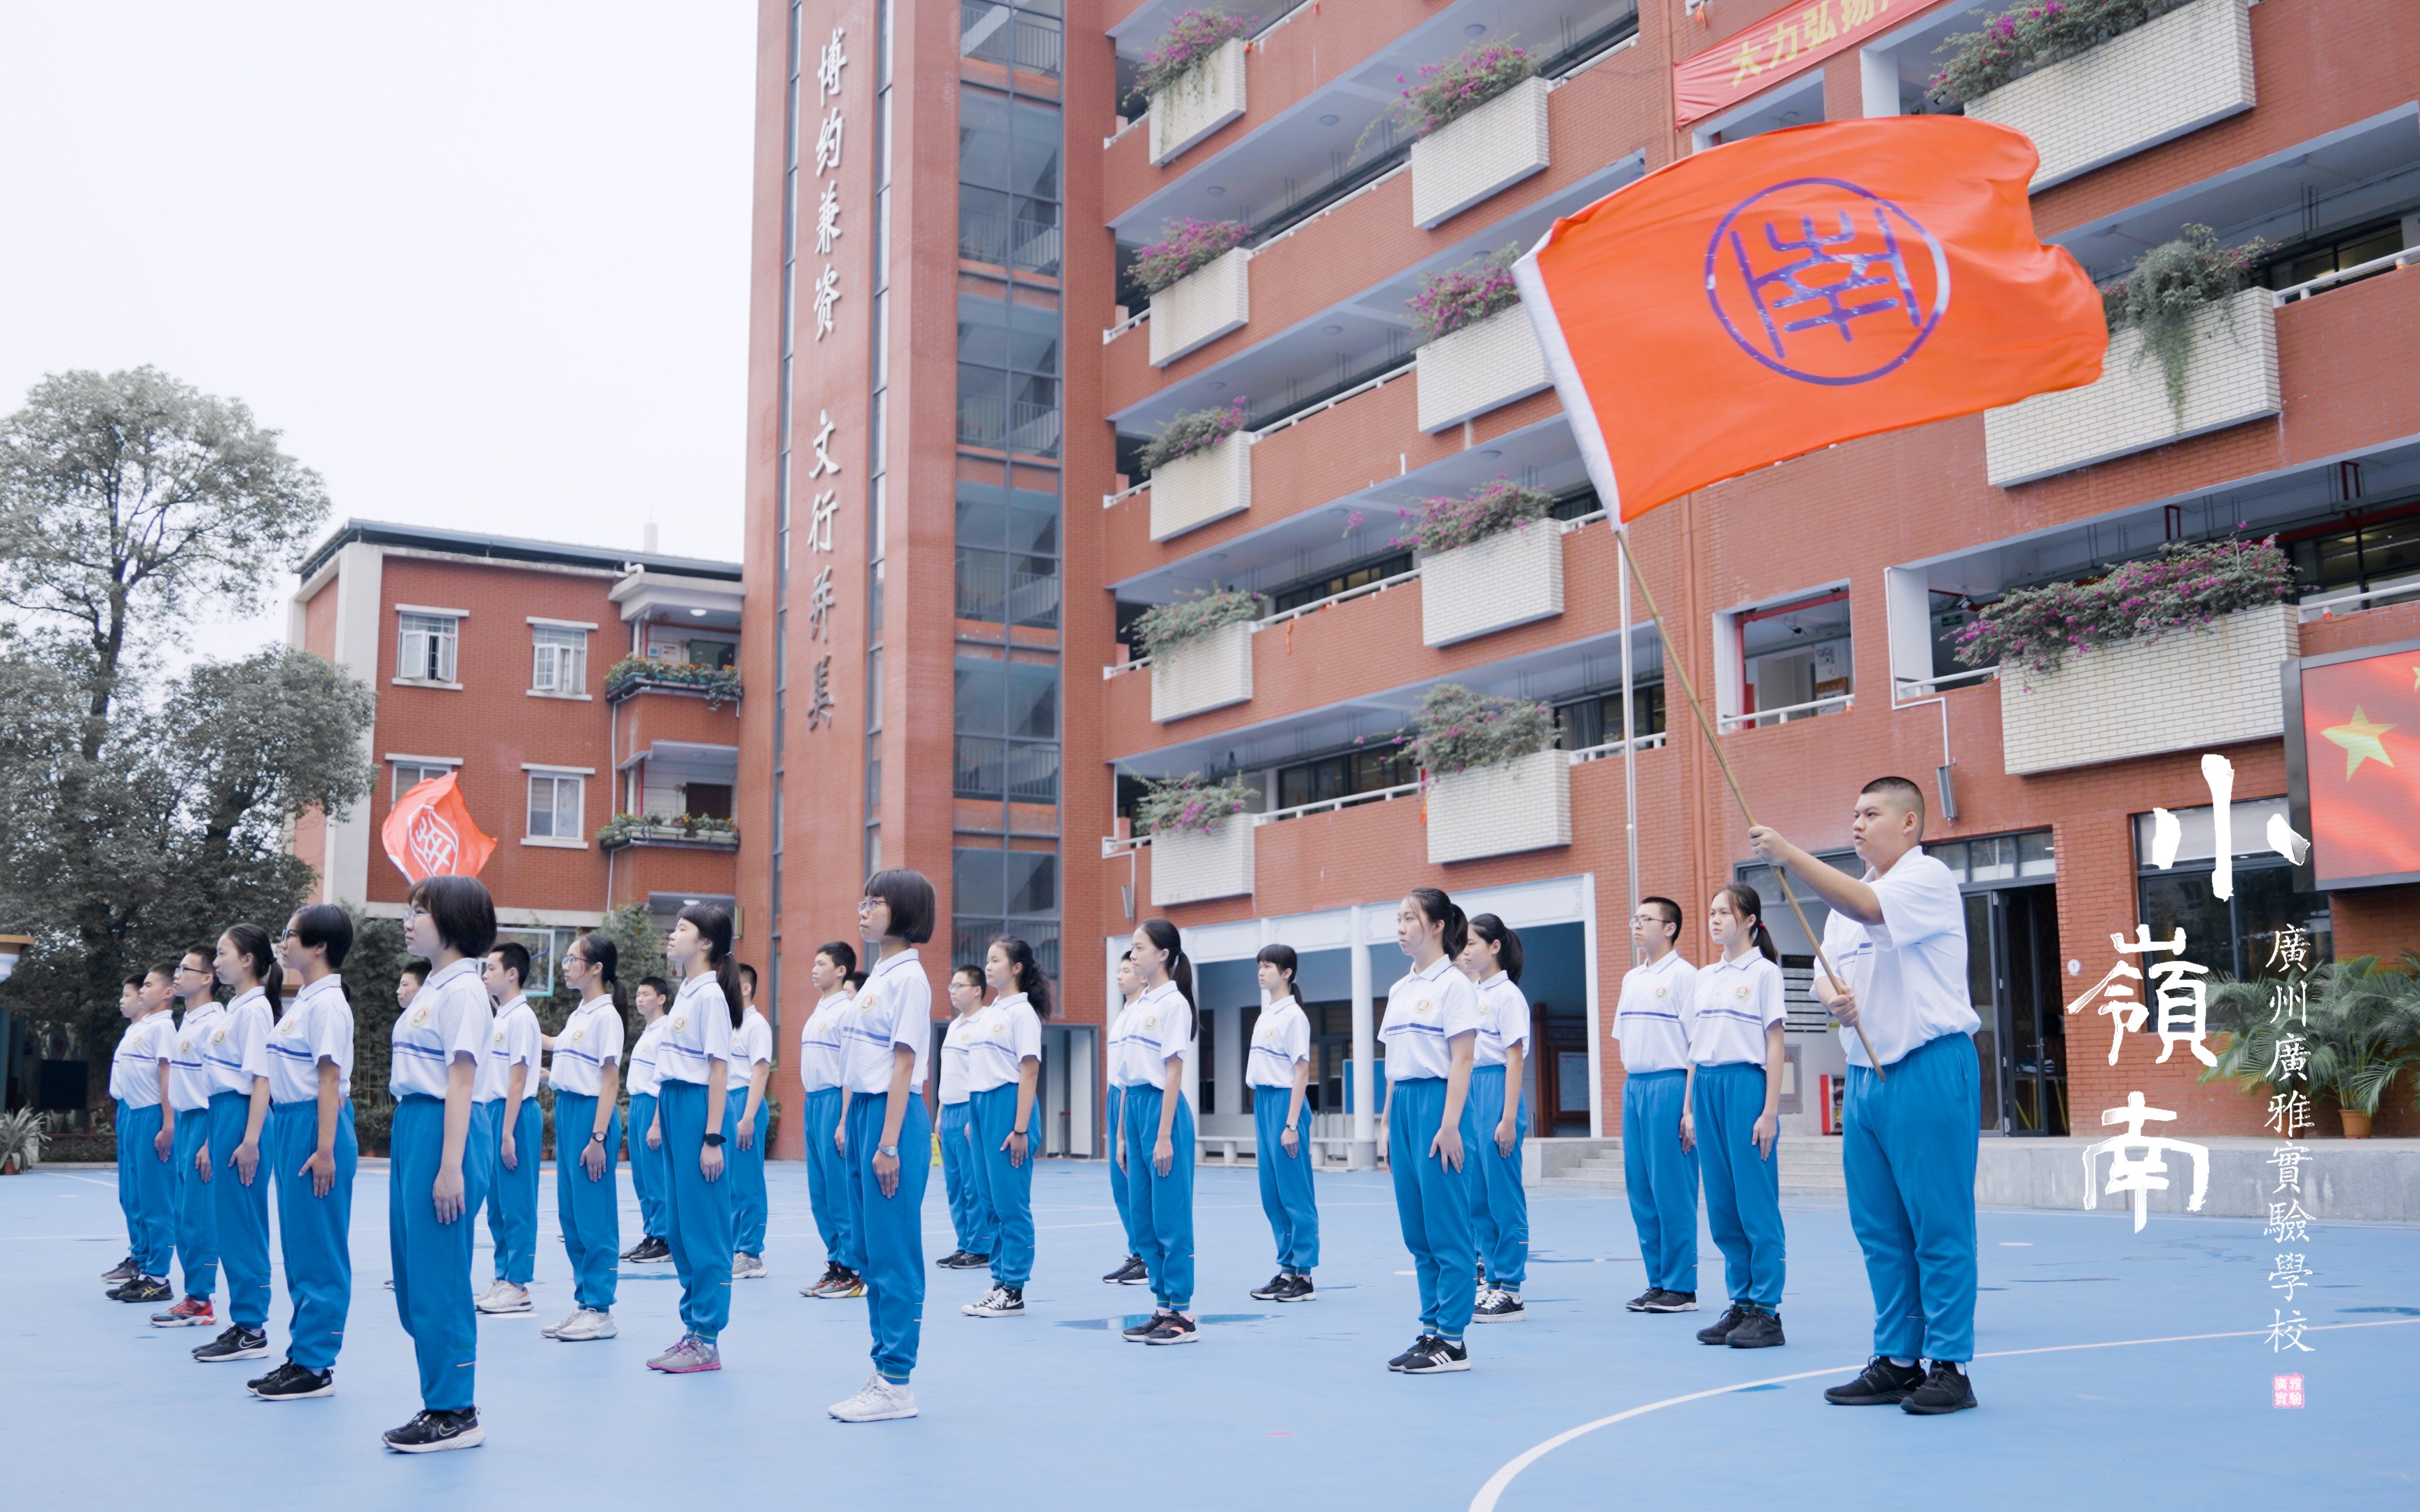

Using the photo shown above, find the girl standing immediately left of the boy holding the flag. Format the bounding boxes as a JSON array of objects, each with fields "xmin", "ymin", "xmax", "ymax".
[{"xmin": 1679, "ymin": 883, "xmax": 1788, "ymax": 1350}]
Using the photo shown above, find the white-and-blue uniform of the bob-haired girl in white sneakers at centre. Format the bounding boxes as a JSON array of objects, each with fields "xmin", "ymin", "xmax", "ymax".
[{"xmin": 842, "ymin": 946, "xmax": 932, "ymax": 1381}]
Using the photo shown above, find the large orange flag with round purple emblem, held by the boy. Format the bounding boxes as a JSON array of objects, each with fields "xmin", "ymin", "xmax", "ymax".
[{"xmin": 1512, "ymin": 116, "xmax": 2108, "ymax": 520}]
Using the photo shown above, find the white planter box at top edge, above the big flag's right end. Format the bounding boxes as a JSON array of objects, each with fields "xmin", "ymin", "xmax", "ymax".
[{"xmin": 1965, "ymin": 0, "xmax": 2255, "ymax": 191}]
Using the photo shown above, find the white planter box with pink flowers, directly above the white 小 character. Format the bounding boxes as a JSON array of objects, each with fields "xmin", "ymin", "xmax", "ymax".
[{"xmin": 1999, "ymin": 605, "xmax": 2302, "ymax": 776}]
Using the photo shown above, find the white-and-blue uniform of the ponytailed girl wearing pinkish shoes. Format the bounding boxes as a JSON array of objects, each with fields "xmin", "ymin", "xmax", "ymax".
[{"xmin": 656, "ymin": 972, "xmax": 738, "ymax": 1343}]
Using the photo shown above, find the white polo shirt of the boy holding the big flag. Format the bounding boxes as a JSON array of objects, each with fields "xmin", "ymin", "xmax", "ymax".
[{"xmin": 1822, "ymin": 849, "xmax": 1982, "ymax": 1067}]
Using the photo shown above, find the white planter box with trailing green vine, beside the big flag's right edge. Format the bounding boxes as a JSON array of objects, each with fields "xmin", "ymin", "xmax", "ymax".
[{"xmin": 1982, "ymin": 288, "xmax": 2284, "ymax": 489}]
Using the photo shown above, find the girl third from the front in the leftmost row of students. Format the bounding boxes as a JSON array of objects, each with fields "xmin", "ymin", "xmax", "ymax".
[{"xmin": 193, "ymin": 924, "xmax": 286, "ymax": 1364}]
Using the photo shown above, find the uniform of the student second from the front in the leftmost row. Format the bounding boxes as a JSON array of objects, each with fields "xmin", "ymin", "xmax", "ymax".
[{"xmin": 261, "ymin": 972, "xmax": 361, "ymax": 1372}]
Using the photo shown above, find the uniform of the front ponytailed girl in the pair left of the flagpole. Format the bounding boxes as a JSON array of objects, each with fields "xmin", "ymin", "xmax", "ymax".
[{"xmin": 1377, "ymin": 955, "xmax": 1481, "ymax": 1343}]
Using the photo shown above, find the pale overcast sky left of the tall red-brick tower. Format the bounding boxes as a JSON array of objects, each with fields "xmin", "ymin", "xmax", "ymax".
[{"xmin": 0, "ymin": 0, "xmax": 755, "ymax": 656}]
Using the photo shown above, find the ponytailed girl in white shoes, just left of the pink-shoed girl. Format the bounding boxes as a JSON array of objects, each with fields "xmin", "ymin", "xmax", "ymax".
[{"xmin": 545, "ymin": 934, "xmax": 622, "ymax": 1343}]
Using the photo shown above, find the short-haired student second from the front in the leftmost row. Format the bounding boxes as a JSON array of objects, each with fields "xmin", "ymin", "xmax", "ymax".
[{"xmin": 247, "ymin": 902, "xmax": 361, "ymax": 1401}]
